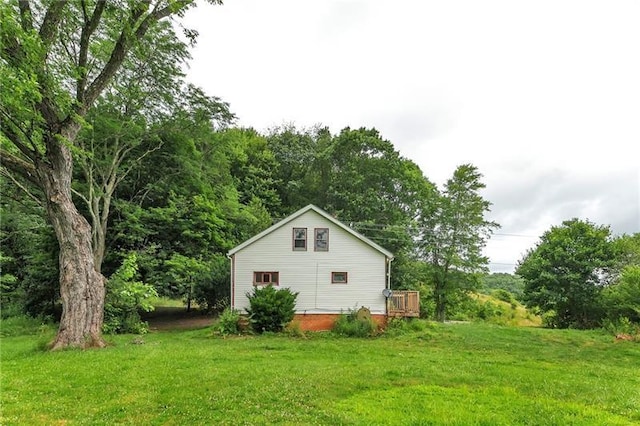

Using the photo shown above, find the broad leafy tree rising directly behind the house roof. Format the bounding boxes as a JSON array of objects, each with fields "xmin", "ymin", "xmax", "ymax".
[{"xmin": 267, "ymin": 126, "xmax": 436, "ymax": 288}]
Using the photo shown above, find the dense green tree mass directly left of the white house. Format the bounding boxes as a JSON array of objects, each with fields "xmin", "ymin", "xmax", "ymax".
[{"xmin": 106, "ymin": 120, "xmax": 277, "ymax": 310}]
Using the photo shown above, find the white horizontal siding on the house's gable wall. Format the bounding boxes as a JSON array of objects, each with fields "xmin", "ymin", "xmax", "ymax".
[{"xmin": 233, "ymin": 210, "xmax": 386, "ymax": 314}]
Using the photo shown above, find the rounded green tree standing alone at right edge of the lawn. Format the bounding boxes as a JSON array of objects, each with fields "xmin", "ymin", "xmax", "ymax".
[{"xmin": 516, "ymin": 219, "xmax": 616, "ymax": 328}]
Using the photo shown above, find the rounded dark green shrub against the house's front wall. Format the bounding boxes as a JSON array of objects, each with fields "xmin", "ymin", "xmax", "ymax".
[{"xmin": 246, "ymin": 285, "xmax": 298, "ymax": 333}]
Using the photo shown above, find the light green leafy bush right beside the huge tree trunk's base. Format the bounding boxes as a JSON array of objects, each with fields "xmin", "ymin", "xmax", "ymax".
[{"xmin": 103, "ymin": 253, "xmax": 158, "ymax": 334}]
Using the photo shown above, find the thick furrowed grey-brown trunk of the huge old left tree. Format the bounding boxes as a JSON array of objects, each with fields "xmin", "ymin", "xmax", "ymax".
[{"xmin": 38, "ymin": 125, "xmax": 105, "ymax": 349}]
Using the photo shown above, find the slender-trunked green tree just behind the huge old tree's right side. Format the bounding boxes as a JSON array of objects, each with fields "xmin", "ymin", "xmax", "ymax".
[{"xmin": 73, "ymin": 22, "xmax": 222, "ymax": 271}]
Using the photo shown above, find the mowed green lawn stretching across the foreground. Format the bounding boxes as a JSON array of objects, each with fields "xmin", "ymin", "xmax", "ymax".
[{"xmin": 0, "ymin": 324, "xmax": 640, "ymax": 425}]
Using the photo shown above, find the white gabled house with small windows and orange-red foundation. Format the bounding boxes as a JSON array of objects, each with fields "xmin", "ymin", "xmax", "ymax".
[{"xmin": 229, "ymin": 204, "xmax": 393, "ymax": 330}]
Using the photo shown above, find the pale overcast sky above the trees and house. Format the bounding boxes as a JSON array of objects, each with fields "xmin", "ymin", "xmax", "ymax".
[{"xmin": 185, "ymin": 0, "xmax": 640, "ymax": 272}]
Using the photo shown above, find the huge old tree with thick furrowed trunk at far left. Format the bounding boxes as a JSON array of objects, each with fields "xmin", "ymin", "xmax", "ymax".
[{"xmin": 0, "ymin": 0, "xmax": 221, "ymax": 349}]
